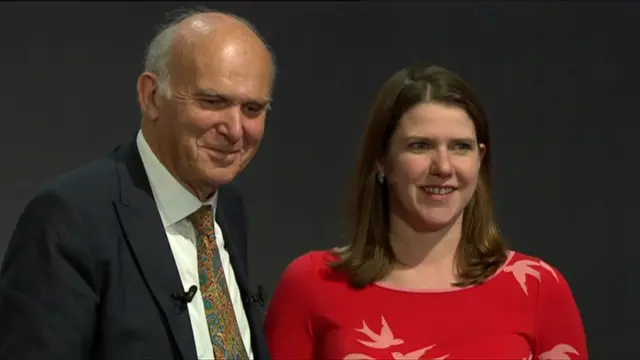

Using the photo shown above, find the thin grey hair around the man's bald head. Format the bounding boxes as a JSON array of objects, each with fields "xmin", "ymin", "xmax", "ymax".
[{"xmin": 144, "ymin": 7, "xmax": 276, "ymax": 98}]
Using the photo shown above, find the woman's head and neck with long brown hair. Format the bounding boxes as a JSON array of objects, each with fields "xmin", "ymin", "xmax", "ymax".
[{"xmin": 334, "ymin": 65, "xmax": 507, "ymax": 288}]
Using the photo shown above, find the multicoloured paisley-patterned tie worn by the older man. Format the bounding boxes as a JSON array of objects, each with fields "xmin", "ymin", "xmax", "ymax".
[{"xmin": 188, "ymin": 205, "xmax": 249, "ymax": 360}]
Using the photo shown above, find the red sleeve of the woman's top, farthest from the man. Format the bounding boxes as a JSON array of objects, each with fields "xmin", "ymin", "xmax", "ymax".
[{"xmin": 536, "ymin": 261, "xmax": 589, "ymax": 360}]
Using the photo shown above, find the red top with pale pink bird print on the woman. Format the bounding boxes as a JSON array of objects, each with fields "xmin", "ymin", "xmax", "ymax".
[{"xmin": 265, "ymin": 251, "xmax": 588, "ymax": 360}]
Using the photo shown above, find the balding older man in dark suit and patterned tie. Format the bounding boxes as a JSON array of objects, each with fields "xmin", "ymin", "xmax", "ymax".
[{"xmin": 0, "ymin": 8, "xmax": 275, "ymax": 360}]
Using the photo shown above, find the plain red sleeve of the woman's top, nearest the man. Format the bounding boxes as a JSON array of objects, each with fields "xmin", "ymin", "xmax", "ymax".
[{"xmin": 264, "ymin": 253, "xmax": 318, "ymax": 360}]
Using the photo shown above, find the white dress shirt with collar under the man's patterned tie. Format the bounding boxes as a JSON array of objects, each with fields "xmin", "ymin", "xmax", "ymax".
[{"xmin": 136, "ymin": 131, "xmax": 253, "ymax": 360}]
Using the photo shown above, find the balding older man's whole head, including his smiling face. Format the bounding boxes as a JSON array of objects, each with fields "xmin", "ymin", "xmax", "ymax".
[{"xmin": 138, "ymin": 11, "xmax": 275, "ymax": 200}]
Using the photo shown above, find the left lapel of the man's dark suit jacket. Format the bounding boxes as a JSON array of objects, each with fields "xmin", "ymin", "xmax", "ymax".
[{"xmin": 114, "ymin": 142, "xmax": 197, "ymax": 360}]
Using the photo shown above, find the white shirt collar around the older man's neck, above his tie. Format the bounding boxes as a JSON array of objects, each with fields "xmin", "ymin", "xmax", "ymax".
[{"xmin": 136, "ymin": 130, "xmax": 218, "ymax": 228}]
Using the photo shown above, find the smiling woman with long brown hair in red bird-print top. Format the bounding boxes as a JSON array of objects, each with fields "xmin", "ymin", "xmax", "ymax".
[{"xmin": 265, "ymin": 65, "xmax": 588, "ymax": 360}]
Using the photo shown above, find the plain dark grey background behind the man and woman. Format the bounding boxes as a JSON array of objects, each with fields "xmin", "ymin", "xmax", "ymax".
[{"xmin": 0, "ymin": 1, "xmax": 640, "ymax": 359}]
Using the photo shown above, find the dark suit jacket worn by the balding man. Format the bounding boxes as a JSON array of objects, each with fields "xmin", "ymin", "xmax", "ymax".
[{"xmin": 0, "ymin": 142, "xmax": 269, "ymax": 360}]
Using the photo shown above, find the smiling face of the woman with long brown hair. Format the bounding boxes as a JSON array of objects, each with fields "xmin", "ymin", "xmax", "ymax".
[{"xmin": 380, "ymin": 103, "xmax": 485, "ymax": 230}]
